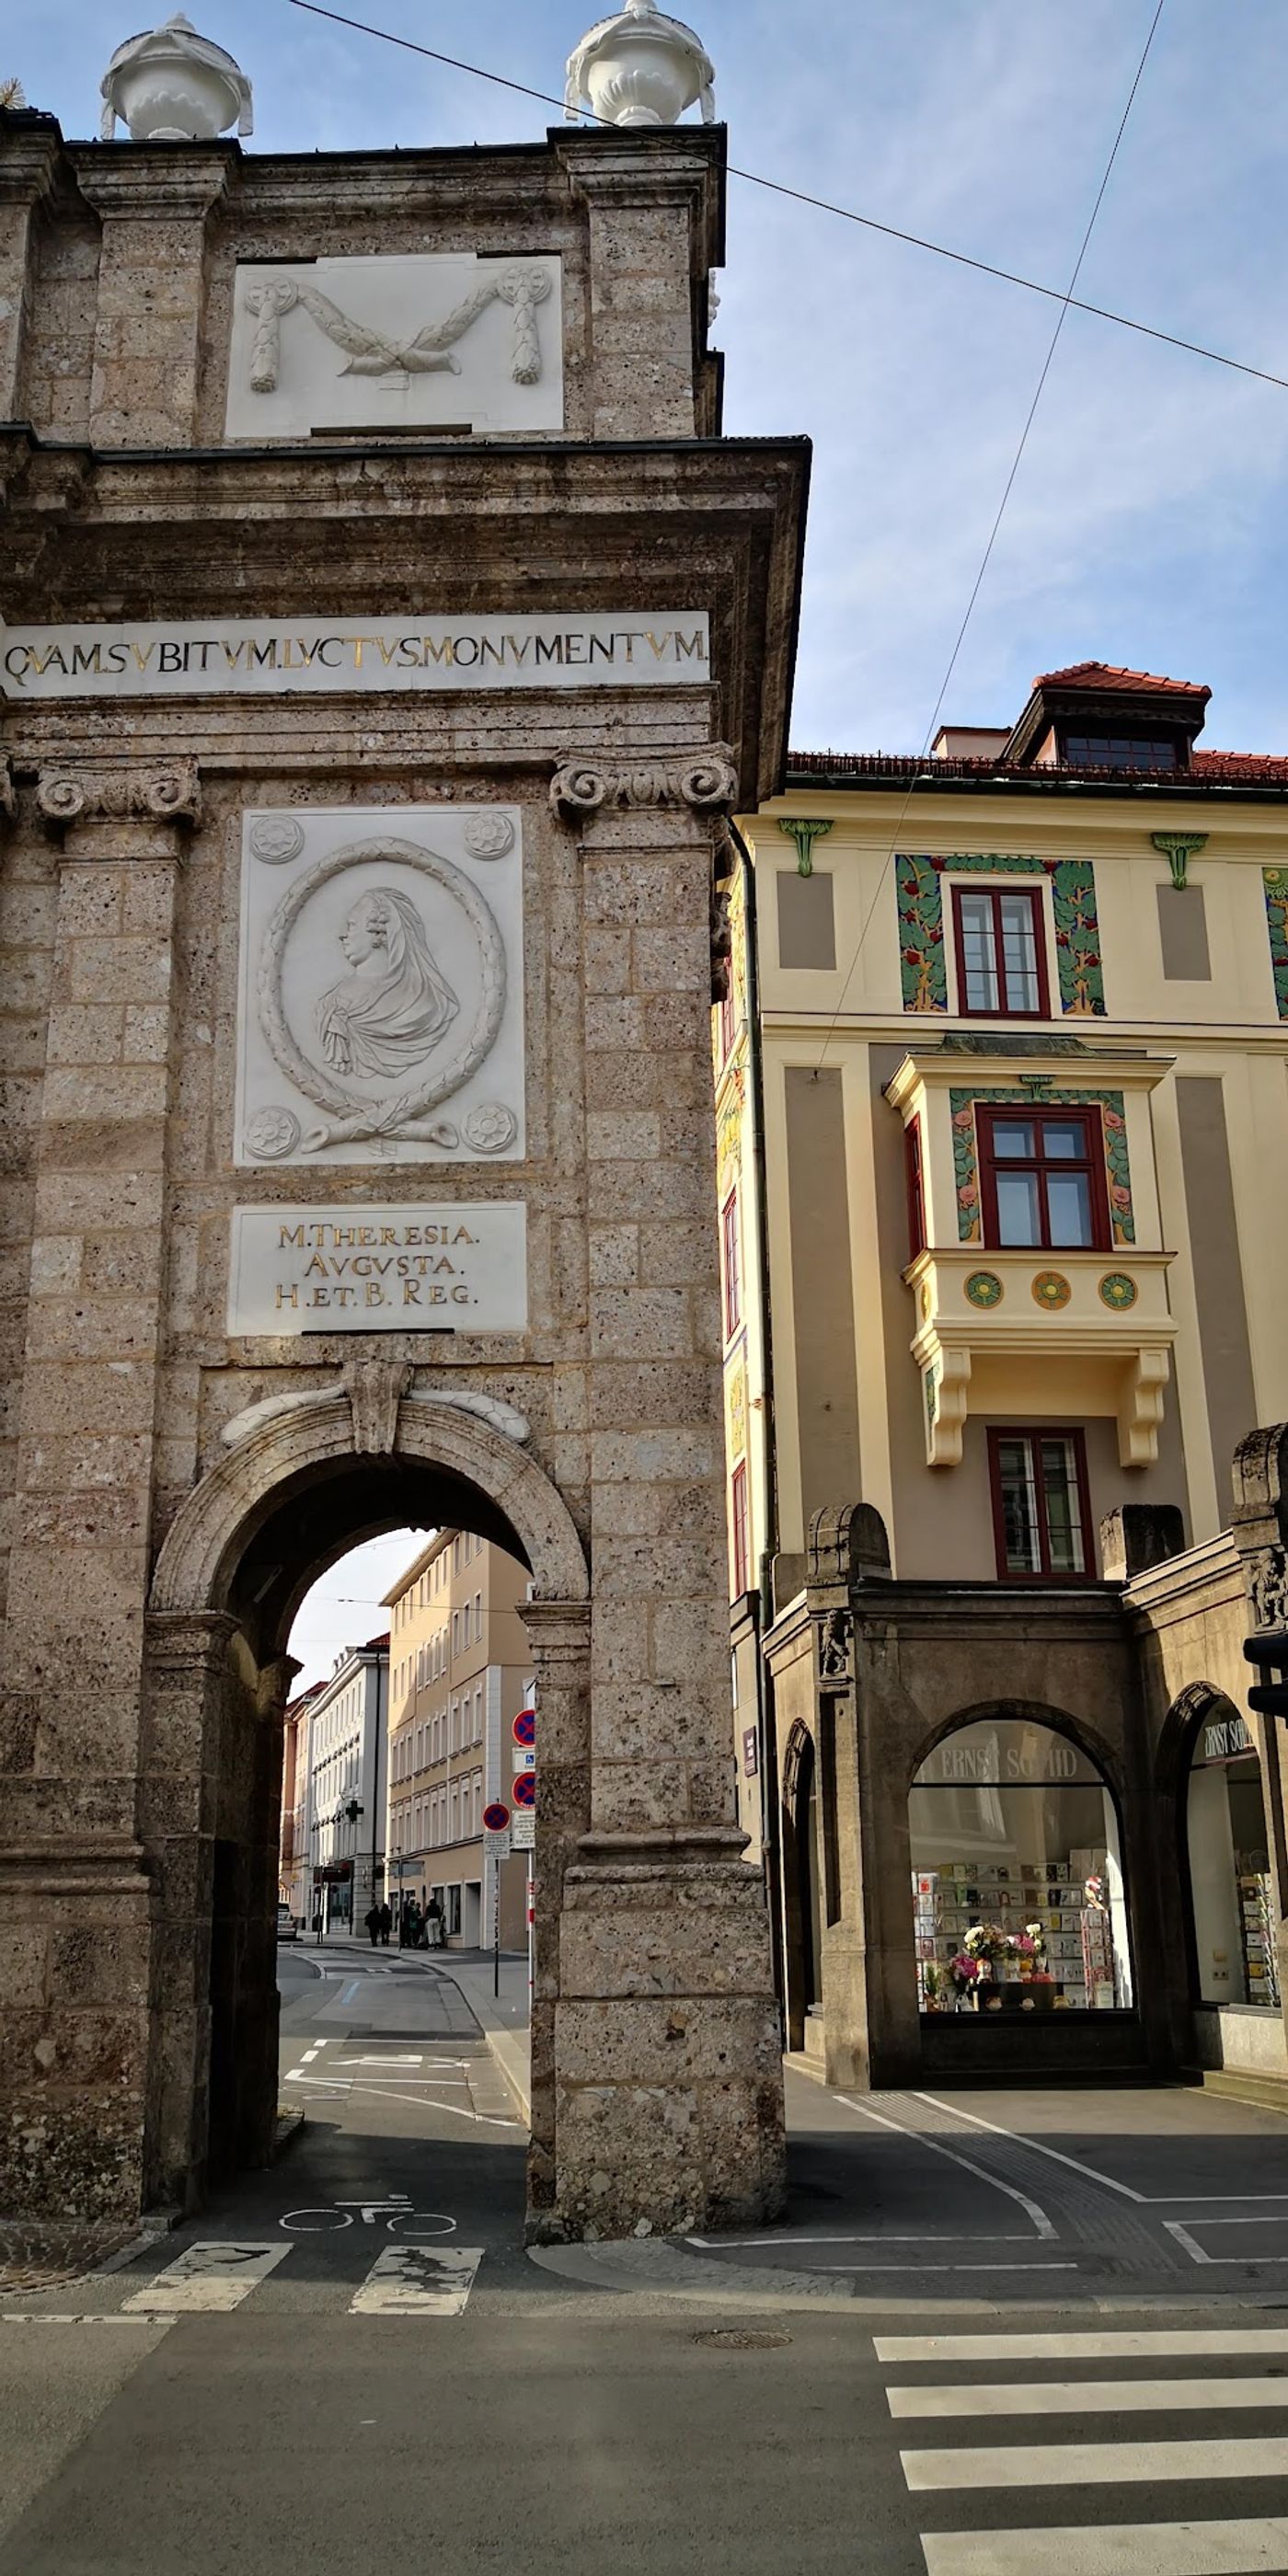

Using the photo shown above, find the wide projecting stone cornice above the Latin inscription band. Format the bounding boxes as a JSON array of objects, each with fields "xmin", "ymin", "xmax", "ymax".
[{"xmin": 0, "ymin": 438, "xmax": 809, "ymax": 801}]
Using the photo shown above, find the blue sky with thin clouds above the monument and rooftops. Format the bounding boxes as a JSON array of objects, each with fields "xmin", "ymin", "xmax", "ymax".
[{"xmin": 0, "ymin": 0, "xmax": 1288, "ymax": 750}]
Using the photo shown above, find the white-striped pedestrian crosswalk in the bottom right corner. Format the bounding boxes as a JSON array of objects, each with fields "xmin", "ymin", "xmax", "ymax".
[{"xmin": 873, "ymin": 2326, "xmax": 1288, "ymax": 2576}]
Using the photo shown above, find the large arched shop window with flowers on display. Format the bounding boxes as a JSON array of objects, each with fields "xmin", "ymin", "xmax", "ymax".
[{"xmin": 909, "ymin": 1719, "xmax": 1131, "ymax": 2012}]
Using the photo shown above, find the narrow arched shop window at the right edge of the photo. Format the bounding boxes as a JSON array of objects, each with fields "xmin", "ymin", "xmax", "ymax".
[{"xmin": 1185, "ymin": 1700, "xmax": 1281, "ymax": 2007}]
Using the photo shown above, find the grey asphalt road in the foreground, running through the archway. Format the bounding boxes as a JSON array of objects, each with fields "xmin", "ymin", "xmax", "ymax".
[{"xmin": 0, "ymin": 1952, "xmax": 1288, "ymax": 2576}]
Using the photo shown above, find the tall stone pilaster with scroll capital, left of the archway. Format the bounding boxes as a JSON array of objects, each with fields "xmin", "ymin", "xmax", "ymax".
[{"xmin": 3, "ymin": 767, "xmax": 196, "ymax": 2210}]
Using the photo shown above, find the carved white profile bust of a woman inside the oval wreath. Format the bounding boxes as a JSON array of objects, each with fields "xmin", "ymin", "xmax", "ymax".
[{"xmin": 316, "ymin": 886, "xmax": 461, "ymax": 1079}]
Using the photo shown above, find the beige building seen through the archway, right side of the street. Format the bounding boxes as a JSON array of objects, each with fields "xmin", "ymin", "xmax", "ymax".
[{"xmin": 384, "ymin": 1530, "xmax": 534, "ymax": 1950}]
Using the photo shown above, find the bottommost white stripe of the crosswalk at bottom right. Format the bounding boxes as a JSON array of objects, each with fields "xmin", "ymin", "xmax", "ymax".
[{"xmin": 922, "ymin": 2519, "xmax": 1288, "ymax": 2576}]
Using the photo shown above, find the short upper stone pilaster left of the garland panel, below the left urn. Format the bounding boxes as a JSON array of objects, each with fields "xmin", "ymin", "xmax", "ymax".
[{"xmin": 75, "ymin": 144, "xmax": 235, "ymax": 448}]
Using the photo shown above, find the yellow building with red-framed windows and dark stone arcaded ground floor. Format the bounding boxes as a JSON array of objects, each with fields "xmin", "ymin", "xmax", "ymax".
[{"xmin": 716, "ymin": 662, "xmax": 1288, "ymax": 2081}]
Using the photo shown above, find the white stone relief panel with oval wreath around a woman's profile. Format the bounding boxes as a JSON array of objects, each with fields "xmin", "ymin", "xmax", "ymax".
[{"xmin": 235, "ymin": 804, "xmax": 525, "ymax": 1169}]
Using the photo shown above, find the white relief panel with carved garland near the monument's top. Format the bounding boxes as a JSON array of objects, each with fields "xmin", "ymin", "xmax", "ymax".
[{"xmin": 226, "ymin": 252, "xmax": 564, "ymax": 441}]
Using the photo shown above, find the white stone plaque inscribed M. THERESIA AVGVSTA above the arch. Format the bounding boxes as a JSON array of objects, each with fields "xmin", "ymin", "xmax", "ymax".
[{"xmin": 229, "ymin": 1198, "xmax": 528, "ymax": 1334}]
